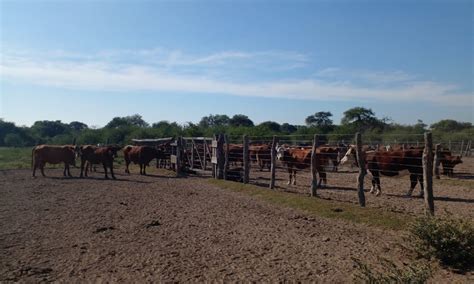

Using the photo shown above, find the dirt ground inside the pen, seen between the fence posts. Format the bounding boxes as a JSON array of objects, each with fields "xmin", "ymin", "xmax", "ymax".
[{"xmin": 250, "ymin": 157, "xmax": 474, "ymax": 218}]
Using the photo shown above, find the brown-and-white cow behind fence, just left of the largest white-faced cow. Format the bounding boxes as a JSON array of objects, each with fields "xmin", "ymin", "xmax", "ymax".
[{"xmin": 276, "ymin": 145, "xmax": 327, "ymax": 187}]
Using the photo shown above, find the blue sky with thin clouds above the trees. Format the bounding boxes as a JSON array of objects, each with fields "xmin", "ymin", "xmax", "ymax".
[{"xmin": 0, "ymin": 0, "xmax": 474, "ymax": 126}]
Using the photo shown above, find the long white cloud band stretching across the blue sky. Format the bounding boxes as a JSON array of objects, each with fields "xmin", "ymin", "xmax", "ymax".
[{"xmin": 0, "ymin": 49, "xmax": 473, "ymax": 106}]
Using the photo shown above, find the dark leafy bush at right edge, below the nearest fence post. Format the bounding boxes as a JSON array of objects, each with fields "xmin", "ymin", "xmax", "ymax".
[{"xmin": 409, "ymin": 217, "xmax": 474, "ymax": 270}]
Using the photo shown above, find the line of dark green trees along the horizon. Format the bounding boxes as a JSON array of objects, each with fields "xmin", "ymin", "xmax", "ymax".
[{"xmin": 0, "ymin": 107, "xmax": 474, "ymax": 147}]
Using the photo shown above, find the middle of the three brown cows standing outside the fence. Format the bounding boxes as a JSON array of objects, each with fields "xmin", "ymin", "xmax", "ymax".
[{"xmin": 80, "ymin": 145, "xmax": 120, "ymax": 179}]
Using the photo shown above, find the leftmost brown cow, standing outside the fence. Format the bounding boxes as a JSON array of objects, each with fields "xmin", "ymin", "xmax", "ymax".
[{"xmin": 31, "ymin": 145, "xmax": 77, "ymax": 177}]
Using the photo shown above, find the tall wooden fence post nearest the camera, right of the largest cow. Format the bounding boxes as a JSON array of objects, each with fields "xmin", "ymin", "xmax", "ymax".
[{"xmin": 423, "ymin": 132, "xmax": 434, "ymax": 216}]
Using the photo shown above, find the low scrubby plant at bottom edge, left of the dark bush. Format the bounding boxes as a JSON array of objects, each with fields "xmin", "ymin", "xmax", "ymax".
[{"xmin": 353, "ymin": 258, "xmax": 431, "ymax": 283}]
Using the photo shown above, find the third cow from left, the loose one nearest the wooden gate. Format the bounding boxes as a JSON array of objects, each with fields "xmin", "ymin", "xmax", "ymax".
[{"xmin": 123, "ymin": 145, "xmax": 165, "ymax": 175}]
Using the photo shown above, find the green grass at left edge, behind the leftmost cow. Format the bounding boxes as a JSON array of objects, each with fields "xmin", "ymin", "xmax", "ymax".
[{"xmin": 0, "ymin": 147, "xmax": 33, "ymax": 170}]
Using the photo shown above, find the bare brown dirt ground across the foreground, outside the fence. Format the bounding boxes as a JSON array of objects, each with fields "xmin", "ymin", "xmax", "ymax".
[{"xmin": 0, "ymin": 165, "xmax": 474, "ymax": 283}]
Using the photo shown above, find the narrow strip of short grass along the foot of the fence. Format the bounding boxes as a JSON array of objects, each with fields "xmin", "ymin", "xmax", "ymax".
[{"xmin": 209, "ymin": 179, "xmax": 413, "ymax": 230}]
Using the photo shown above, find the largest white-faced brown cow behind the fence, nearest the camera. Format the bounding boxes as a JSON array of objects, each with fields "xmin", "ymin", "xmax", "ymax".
[{"xmin": 341, "ymin": 146, "xmax": 423, "ymax": 196}]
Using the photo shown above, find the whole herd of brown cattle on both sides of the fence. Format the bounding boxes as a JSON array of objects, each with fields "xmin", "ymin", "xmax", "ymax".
[{"xmin": 32, "ymin": 143, "xmax": 462, "ymax": 196}]
